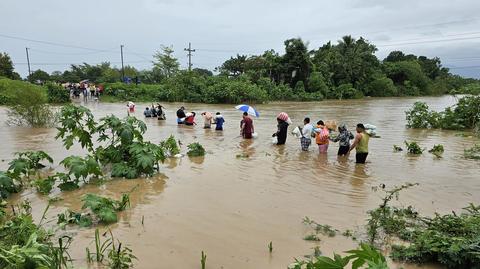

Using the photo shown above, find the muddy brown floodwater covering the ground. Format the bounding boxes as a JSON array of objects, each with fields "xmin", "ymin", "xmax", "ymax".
[{"xmin": 0, "ymin": 96, "xmax": 480, "ymax": 269}]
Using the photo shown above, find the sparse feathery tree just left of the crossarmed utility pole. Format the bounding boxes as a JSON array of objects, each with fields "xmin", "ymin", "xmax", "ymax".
[{"xmin": 153, "ymin": 45, "xmax": 180, "ymax": 81}]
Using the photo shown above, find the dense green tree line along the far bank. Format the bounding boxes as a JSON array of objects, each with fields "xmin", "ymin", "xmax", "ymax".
[{"xmin": 0, "ymin": 36, "xmax": 478, "ymax": 102}]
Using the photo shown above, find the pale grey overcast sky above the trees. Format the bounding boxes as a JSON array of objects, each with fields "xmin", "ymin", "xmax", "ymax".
[{"xmin": 0, "ymin": 0, "xmax": 480, "ymax": 78}]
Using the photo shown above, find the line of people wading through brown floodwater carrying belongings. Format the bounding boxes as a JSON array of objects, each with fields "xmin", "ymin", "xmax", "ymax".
[{"xmin": 144, "ymin": 104, "xmax": 371, "ymax": 164}]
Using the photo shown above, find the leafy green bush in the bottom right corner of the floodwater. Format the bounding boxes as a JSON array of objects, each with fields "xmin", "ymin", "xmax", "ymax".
[{"xmin": 367, "ymin": 184, "xmax": 480, "ymax": 268}]
